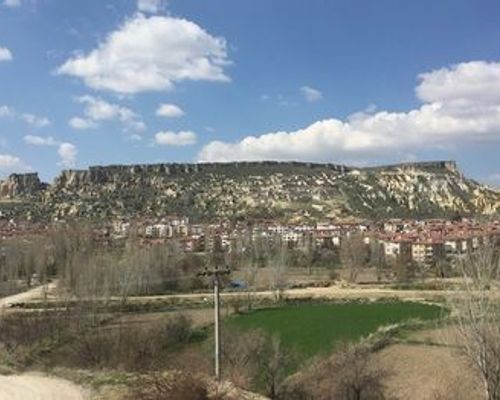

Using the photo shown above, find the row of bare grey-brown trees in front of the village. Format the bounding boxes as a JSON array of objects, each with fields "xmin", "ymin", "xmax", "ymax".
[{"xmin": 0, "ymin": 224, "xmax": 480, "ymax": 298}]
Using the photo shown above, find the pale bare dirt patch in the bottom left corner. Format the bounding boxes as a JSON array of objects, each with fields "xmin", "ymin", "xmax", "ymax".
[{"xmin": 0, "ymin": 374, "xmax": 90, "ymax": 400}]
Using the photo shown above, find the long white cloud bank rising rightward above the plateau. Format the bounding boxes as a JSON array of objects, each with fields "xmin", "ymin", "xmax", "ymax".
[{"xmin": 198, "ymin": 61, "xmax": 500, "ymax": 162}]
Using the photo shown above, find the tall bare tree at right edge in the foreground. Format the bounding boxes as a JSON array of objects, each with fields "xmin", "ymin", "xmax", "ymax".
[{"xmin": 451, "ymin": 248, "xmax": 500, "ymax": 400}]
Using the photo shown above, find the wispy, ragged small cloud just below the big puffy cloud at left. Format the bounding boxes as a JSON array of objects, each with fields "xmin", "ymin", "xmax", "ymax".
[{"xmin": 69, "ymin": 95, "xmax": 146, "ymax": 132}]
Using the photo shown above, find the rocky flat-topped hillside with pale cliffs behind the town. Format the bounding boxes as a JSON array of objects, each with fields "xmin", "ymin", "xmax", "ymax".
[{"xmin": 0, "ymin": 161, "xmax": 500, "ymax": 221}]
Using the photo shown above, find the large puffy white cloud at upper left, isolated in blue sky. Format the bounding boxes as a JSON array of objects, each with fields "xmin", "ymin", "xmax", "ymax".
[{"xmin": 57, "ymin": 13, "xmax": 229, "ymax": 94}]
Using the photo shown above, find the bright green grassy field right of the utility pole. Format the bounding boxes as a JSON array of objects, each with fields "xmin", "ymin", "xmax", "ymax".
[{"xmin": 228, "ymin": 302, "xmax": 443, "ymax": 357}]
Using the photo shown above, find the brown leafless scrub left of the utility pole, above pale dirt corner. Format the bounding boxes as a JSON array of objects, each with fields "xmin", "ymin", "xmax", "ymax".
[{"xmin": 0, "ymin": 307, "xmax": 205, "ymax": 372}]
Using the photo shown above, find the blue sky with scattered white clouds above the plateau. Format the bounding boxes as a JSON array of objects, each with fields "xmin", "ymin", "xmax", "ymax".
[{"xmin": 0, "ymin": 0, "xmax": 500, "ymax": 185}]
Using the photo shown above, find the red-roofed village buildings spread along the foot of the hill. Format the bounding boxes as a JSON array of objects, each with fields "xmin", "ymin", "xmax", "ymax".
[{"xmin": 0, "ymin": 216, "xmax": 500, "ymax": 266}]
